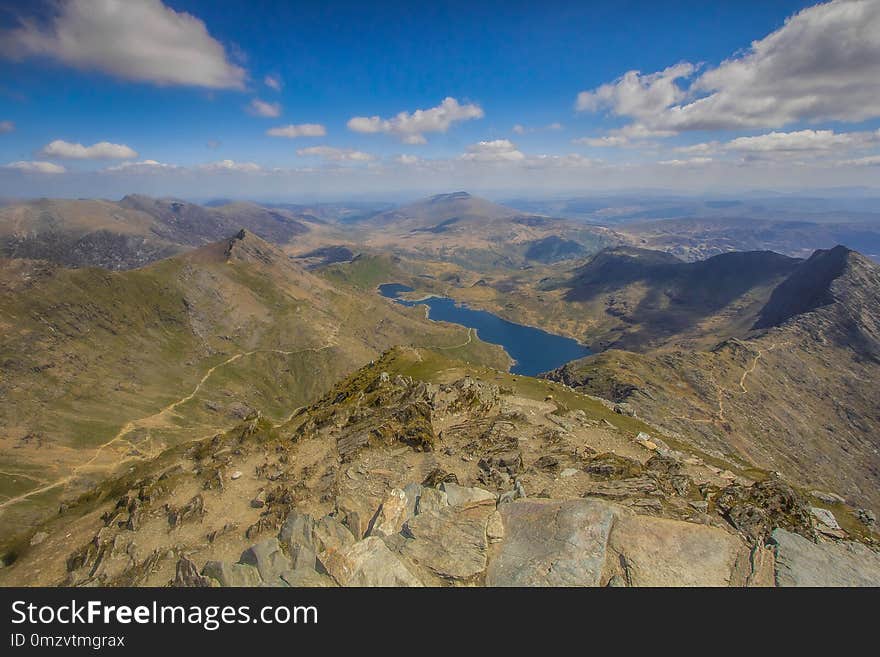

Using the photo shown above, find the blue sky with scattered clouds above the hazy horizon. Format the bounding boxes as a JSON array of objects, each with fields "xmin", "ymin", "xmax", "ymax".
[{"xmin": 0, "ymin": 0, "xmax": 880, "ymax": 198}]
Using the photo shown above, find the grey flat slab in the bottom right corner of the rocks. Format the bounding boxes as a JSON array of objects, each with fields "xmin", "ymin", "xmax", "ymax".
[{"xmin": 770, "ymin": 528, "xmax": 880, "ymax": 586}]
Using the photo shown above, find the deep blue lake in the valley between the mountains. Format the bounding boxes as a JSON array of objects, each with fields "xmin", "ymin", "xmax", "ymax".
[{"xmin": 379, "ymin": 283, "xmax": 590, "ymax": 376}]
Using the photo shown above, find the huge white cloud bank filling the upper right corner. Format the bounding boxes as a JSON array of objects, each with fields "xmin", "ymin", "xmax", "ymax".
[{"xmin": 576, "ymin": 0, "xmax": 880, "ymax": 132}]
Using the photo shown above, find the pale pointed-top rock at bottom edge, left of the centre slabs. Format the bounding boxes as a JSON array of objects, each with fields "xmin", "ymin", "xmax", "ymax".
[{"xmin": 319, "ymin": 536, "xmax": 422, "ymax": 587}]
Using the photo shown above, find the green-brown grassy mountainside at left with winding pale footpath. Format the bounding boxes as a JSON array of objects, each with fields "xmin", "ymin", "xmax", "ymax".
[{"xmin": 0, "ymin": 237, "xmax": 507, "ymax": 548}]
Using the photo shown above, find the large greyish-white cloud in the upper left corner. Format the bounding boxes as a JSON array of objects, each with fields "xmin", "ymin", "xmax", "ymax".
[{"xmin": 0, "ymin": 0, "xmax": 245, "ymax": 89}]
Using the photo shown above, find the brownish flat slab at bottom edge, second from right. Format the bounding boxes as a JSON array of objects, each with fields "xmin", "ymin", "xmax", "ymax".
[{"xmin": 609, "ymin": 515, "xmax": 747, "ymax": 586}]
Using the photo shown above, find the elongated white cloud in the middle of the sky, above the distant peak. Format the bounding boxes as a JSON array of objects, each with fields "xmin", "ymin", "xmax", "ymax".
[{"xmin": 348, "ymin": 97, "xmax": 484, "ymax": 144}]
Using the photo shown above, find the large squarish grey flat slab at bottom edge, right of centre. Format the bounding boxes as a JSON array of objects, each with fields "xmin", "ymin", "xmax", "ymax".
[{"xmin": 486, "ymin": 500, "xmax": 615, "ymax": 586}]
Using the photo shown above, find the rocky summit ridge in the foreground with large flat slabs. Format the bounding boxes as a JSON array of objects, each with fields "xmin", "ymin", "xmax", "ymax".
[{"xmin": 0, "ymin": 349, "xmax": 880, "ymax": 586}]
